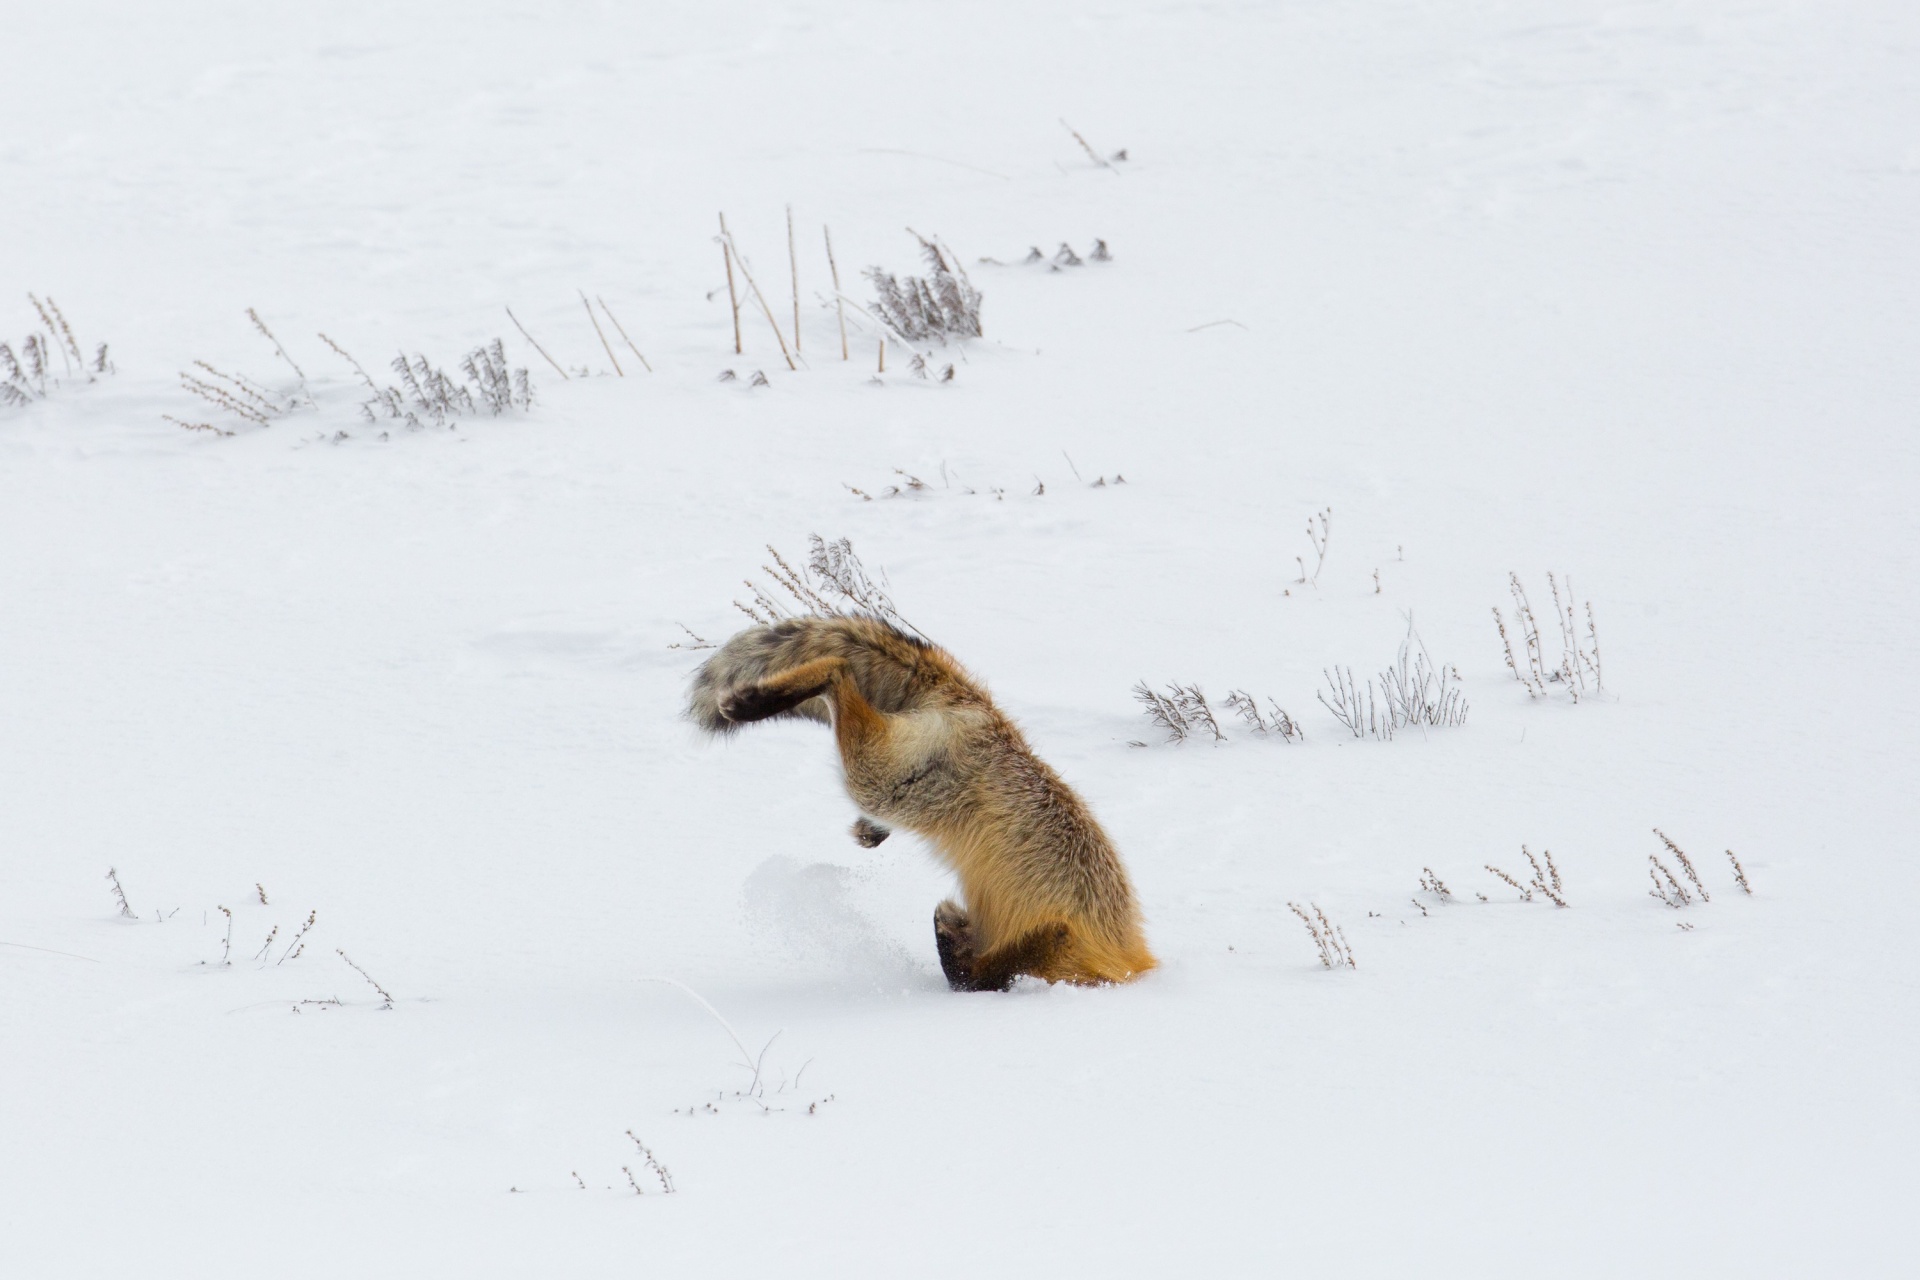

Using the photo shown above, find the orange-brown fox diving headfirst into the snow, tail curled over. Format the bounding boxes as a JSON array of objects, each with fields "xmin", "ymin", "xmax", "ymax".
[{"xmin": 687, "ymin": 616, "xmax": 1156, "ymax": 990}]
